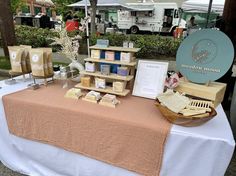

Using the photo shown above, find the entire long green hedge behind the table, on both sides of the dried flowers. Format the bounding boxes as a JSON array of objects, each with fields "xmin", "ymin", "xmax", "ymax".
[{"xmin": 13, "ymin": 26, "xmax": 182, "ymax": 59}]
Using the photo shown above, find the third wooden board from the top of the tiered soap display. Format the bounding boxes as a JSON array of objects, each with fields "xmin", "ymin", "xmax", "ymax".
[{"xmin": 80, "ymin": 71, "xmax": 134, "ymax": 81}]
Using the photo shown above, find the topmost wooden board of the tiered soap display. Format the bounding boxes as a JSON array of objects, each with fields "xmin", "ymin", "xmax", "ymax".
[{"xmin": 89, "ymin": 45, "xmax": 140, "ymax": 53}]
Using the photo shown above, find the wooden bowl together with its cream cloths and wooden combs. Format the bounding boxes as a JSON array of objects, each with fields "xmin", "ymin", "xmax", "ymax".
[{"xmin": 156, "ymin": 89, "xmax": 217, "ymax": 127}]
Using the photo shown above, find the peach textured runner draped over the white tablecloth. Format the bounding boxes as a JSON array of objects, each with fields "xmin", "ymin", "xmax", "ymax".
[{"xmin": 3, "ymin": 84, "xmax": 171, "ymax": 176}]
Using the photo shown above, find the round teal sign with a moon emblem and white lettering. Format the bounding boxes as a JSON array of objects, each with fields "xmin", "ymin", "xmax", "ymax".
[{"xmin": 176, "ymin": 29, "xmax": 234, "ymax": 83}]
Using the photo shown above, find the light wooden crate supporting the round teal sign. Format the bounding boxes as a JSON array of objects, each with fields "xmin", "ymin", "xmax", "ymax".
[{"xmin": 175, "ymin": 79, "xmax": 226, "ymax": 107}]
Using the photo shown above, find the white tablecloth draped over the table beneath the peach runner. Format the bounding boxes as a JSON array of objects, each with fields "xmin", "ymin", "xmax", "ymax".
[{"xmin": 0, "ymin": 77, "xmax": 235, "ymax": 176}]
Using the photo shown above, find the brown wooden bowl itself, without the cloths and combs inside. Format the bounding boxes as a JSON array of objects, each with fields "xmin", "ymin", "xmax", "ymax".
[{"xmin": 156, "ymin": 101, "xmax": 217, "ymax": 127}]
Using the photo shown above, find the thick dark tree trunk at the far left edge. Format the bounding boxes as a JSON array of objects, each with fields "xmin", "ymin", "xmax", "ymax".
[{"xmin": 0, "ymin": 0, "xmax": 16, "ymax": 56}]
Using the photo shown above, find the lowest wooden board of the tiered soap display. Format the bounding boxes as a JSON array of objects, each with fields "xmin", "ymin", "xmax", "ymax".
[{"xmin": 75, "ymin": 83, "xmax": 130, "ymax": 96}]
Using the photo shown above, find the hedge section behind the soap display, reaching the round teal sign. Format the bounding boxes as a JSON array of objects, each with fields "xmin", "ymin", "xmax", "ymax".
[{"xmin": 89, "ymin": 34, "xmax": 182, "ymax": 59}]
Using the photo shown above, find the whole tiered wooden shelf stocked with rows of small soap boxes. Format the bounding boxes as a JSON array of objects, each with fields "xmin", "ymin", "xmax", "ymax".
[{"xmin": 75, "ymin": 46, "xmax": 140, "ymax": 96}]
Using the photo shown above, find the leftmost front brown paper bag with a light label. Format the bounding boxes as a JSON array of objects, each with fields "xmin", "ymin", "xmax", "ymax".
[{"xmin": 8, "ymin": 46, "xmax": 25, "ymax": 73}]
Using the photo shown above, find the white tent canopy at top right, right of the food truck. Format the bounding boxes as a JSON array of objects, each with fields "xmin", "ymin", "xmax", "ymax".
[{"xmin": 182, "ymin": 0, "xmax": 225, "ymax": 14}]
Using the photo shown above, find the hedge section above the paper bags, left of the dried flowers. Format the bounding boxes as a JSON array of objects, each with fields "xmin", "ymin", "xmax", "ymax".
[{"xmin": 15, "ymin": 25, "xmax": 58, "ymax": 48}]
